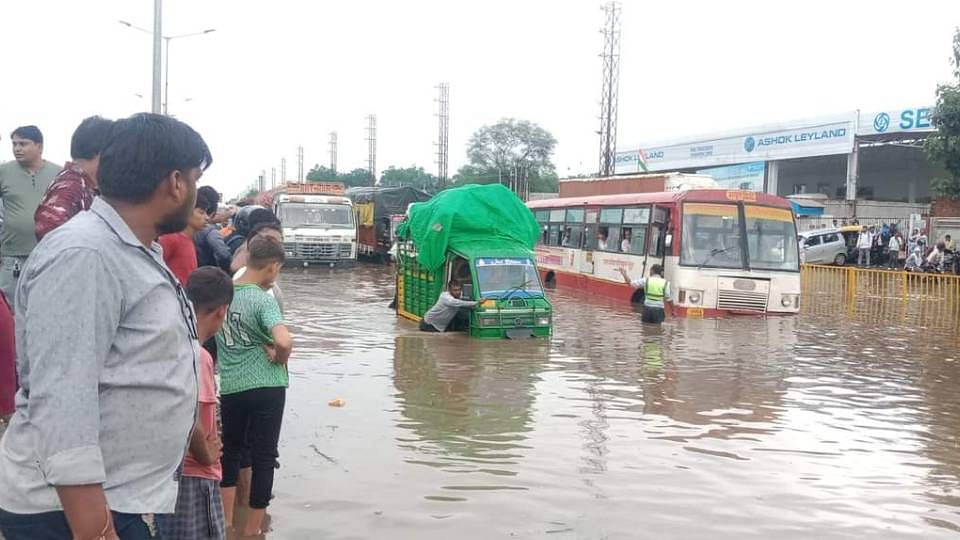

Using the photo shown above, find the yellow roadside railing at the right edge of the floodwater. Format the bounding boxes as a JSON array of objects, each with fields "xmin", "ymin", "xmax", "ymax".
[{"xmin": 800, "ymin": 264, "xmax": 960, "ymax": 327}]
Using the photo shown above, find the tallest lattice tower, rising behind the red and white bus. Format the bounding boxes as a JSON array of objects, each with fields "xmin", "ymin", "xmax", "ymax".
[{"xmin": 600, "ymin": 2, "xmax": 622, "ymax": 176}]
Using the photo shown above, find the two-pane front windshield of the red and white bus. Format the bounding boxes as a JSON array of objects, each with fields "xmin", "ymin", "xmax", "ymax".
[{"xmin": 680, "ymin": 203, "xmax": 800, "ymax": 271}]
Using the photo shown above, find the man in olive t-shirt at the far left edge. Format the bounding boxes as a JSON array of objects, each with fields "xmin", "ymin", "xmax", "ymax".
[{"xmin": 0, "ymin": 126, "xmax": 62, "ymax": 307}]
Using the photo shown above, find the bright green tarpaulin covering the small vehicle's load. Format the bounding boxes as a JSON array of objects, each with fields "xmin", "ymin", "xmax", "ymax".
[{"xmin": 397, "ymin": 184, "xmax": 540, "ymax": 270}]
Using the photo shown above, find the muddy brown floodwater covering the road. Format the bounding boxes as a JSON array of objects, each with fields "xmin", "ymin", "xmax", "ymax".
[{"xmin": 260, "ymin": 265, "xmax": 960, "ymax": 539}]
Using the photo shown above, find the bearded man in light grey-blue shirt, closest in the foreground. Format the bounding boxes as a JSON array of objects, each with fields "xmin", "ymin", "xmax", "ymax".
[{"xmin": 0, "ymin": 113, "xmax": 212, "ymax": 540}]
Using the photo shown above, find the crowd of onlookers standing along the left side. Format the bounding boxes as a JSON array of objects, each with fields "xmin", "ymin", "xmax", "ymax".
[{"xmin": 0, "ymin": 114, "xmax": 292, "ymax": 540}]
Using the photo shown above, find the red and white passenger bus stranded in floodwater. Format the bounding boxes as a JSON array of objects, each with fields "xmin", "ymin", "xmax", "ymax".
[{"xmin": 527, "ymin": 189, "xmax": 800, "ymax": 316}]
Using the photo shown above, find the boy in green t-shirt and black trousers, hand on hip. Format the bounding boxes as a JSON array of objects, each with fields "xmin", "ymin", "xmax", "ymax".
[{"xmin": 217, "ymin": 236, "xmax": 293, "ymax": 536}]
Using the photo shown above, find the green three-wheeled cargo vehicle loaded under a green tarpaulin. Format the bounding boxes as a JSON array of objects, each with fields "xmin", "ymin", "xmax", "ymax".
[{"xmin": 396, "ymin": 185, "xmax": 553, "ymax": 339}]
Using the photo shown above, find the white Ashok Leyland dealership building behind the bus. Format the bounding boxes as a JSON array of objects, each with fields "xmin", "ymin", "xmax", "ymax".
[{"xmin": 615, "ymin": 106, "xmax": 946, "ymax": 217}]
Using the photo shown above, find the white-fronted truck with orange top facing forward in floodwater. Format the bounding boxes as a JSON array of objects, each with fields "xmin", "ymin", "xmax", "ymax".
[{"xmin": 257, "ymin": 182, "xmax": 357, "ymax": 266}]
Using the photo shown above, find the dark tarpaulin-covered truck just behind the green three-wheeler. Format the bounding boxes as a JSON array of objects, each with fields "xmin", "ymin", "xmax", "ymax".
[{"xmin": 347, "ymin": 186, "xmax": 430, "ymax": 261}]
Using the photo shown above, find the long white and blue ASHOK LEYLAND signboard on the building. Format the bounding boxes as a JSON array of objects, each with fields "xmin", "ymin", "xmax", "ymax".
[{"xmin": 615, "ymin": 114, "xmax": 854, "ymax": 174}]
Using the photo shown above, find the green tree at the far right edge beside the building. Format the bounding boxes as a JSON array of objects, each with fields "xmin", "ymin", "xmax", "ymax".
[{"xmin": 924, "ymin": 27, "xmax": 960, "ymax": 198}]
